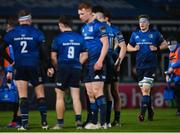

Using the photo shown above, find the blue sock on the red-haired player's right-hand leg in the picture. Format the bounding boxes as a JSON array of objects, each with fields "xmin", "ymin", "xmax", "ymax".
[{"xmin": 96, "ymin": 95, "xmax": 107, "ymax": 126}]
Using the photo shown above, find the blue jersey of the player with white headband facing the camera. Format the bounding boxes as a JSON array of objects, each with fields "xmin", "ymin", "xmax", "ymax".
[{"xmin": 129, "ymin": 29, "xmax": 164, "ymax": 69}]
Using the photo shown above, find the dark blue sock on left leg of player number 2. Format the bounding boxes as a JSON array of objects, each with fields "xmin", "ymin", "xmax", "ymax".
[{"xmin": 20, "ymin": 97, "xmax": 29, "ymax": 128}]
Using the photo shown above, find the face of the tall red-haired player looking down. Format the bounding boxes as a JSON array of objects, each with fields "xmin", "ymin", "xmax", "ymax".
[{"xmin": 78, "ymin": 8, "xmax": 92, "ymax": 23}]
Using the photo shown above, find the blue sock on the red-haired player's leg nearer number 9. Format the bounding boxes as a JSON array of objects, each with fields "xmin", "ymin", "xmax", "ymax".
[{"xmin": 90, "ymin": 102, "xmax": 98, "ymax": 124}]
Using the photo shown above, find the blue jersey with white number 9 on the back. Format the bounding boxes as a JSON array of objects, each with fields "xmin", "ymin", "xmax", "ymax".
[{"xmin": 52, "ymin": 31, "xmax": 86, "ymax": 69}]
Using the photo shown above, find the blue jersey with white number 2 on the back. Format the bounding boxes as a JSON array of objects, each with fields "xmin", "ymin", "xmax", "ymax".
[{"xmin": 4, "ymin": 25, "xmax": 45, "ymax": 67}]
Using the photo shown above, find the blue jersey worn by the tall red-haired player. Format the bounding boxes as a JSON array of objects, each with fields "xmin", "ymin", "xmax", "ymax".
[{"xmin": 82, "ymin": 20, "xmax": 107, "ymax": 67}]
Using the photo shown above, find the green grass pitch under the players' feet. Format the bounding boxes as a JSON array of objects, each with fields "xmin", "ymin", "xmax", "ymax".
[{"xmin": 0, "ymin": 108, "xmax": 180, "ymax": 132}]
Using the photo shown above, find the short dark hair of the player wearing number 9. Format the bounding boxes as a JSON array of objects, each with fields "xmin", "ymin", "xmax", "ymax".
[{"xmin": 59, "ymin": 16, "xmax": 73, "ymax": 27}]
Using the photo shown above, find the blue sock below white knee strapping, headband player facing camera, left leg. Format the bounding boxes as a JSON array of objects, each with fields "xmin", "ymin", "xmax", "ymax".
[{"xmin": 141, "ymin": 95, "xmax": 150, "ymax": 115}]
